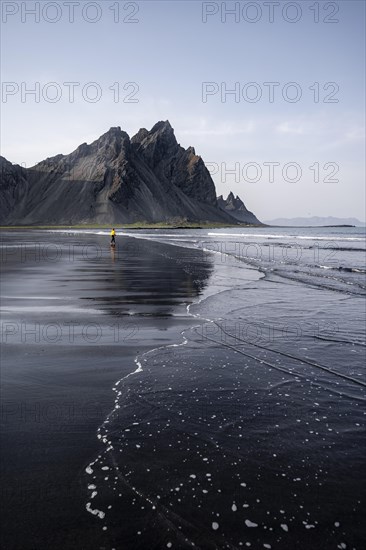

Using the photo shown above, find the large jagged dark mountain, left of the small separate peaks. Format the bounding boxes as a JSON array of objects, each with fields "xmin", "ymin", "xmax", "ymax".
[{"xmin": 0, "ymin": 121, "xmax": 260, "ymax": 225}]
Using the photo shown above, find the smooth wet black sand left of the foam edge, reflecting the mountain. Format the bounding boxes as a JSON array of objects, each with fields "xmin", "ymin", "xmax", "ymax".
[{"xmin": 1, "ymin": 232, "xmax": 212, "ymax": 550}]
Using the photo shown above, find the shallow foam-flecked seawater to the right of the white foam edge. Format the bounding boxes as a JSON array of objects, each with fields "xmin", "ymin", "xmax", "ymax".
[{"xmin": 76, "ymin": 226, "xmax": 366, "ymax": 549}]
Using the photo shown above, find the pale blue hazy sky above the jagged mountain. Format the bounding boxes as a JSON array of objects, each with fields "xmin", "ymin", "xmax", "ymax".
[{"xmin": 1, "ymin": 0, "xmax": 365, "ymax": 220}]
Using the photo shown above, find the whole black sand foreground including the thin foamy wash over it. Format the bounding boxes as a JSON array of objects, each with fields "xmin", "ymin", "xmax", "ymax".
[{"xmin": 1, "ymin": 231, "xmax": 365, "ymax": 550}]
